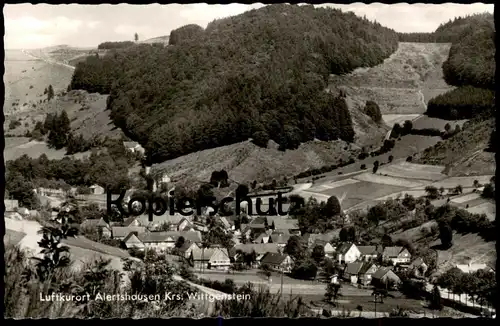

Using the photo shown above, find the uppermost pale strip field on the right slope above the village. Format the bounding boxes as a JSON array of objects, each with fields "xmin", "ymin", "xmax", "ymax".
[{"xmin": 378, "ymin": 162, "xmax": 446, "ymax": 181}]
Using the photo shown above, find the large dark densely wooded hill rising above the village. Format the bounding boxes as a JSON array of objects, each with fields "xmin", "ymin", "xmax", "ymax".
[{"xmin": 70, "ymin": 4, "xmax": 398, "ymax": 162}]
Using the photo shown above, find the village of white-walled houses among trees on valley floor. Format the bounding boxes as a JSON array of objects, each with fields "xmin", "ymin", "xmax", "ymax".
[{"xmin": 5, "ymin": 138, "xmax": 495, "ymax": 316}]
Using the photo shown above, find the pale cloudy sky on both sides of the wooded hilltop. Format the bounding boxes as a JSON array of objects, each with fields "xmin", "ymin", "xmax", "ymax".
[{"xmin": 3, "ymin": 3, "xmax": 494, "ymax": 49}]
